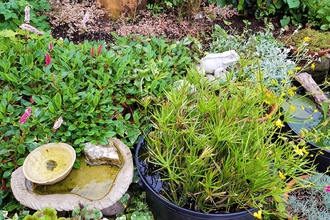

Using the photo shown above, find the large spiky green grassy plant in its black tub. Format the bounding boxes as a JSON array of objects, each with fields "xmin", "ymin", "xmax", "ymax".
[{"xmin": 135, "ymin": 72, "xmax": 312, "ymax": 219}]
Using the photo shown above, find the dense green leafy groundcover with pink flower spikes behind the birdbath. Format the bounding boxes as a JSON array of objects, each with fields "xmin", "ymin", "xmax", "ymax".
[{"xmin": 0, "ymin": 30, "xmax": 193, "ymax": 212}]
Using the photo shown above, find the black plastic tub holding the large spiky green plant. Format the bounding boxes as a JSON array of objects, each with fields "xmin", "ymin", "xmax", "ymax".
[{"xmin": 135, "ymin": 137, "xmax": 258, "ymax": 220}]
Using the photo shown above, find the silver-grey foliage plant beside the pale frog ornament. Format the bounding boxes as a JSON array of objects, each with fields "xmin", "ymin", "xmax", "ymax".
[{"xmin": 210, "ymin": 26, "xmax": 296, "ymax": 93}]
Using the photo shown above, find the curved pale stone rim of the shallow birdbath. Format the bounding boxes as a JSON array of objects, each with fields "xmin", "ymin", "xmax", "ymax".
[{"xmin": 11, "ymin": 138, "xmax": 134, "ymax": 211}]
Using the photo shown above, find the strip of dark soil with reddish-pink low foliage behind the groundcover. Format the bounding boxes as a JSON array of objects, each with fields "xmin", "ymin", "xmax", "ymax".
[{"xmin": 50, "ymin": 2, "xmax": 293, "ymax": 43}]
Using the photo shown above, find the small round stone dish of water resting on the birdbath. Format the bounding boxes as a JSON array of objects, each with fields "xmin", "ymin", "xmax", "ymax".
[{"xmin": 23, "ymin": 143, "xmax": 76, "ymax": 185}]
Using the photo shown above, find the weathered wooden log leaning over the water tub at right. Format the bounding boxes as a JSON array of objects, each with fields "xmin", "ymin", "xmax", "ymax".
[{"xmin": 295, "ymin": 72, "xmax": 330, "ymax": 117}]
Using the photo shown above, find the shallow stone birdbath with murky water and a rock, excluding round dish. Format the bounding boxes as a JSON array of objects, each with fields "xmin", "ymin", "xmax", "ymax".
[{"xmin": 11, "ymin": 138, "xmax": 133, "ymax": 215}]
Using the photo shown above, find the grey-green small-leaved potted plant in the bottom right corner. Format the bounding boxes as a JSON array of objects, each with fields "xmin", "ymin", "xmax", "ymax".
[{"xmin": 284, "ymin": 173, "xmax": 330, "ymax": 220}]
